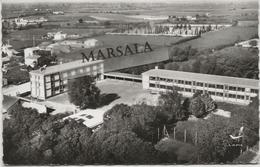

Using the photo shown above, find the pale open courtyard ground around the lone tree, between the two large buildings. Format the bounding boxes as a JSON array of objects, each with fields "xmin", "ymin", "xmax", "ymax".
[{"xmin": 43, "ymin": 79, "xmax": 158, "ymax": 115}]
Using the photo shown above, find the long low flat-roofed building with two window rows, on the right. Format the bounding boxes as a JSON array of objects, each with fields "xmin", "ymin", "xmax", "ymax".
[{"xmin": 142, "ymin": 69, "xmax": 259, "ymax": 105}]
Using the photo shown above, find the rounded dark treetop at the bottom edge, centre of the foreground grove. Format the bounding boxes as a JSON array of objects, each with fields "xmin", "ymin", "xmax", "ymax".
[{"xmin": 101, "ymin": 131, "xmax": 156, "ymax": 164}]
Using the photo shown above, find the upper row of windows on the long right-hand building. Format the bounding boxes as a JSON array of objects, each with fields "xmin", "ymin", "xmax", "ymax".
[{"xmin": 150, "ymin": 77, "xmax": 258, "ymax": 93}]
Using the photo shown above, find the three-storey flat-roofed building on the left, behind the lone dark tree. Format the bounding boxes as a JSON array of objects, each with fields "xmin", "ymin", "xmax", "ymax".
[{"xmin": 30, "ymin": 60, "xmax": 104, "ymax": 100}]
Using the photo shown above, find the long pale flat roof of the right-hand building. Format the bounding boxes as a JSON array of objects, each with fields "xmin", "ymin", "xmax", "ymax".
[{"xmin": 142, "ymin": 69, "xmax": 259, "ymax": 89}]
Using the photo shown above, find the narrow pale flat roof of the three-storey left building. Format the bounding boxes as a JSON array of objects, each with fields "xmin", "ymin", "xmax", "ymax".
[{"xmin": 30, "ymin": 60, "xmax": 104, "ymax": 75}]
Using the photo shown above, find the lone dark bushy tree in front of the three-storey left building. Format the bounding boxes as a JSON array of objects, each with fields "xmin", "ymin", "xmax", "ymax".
[{"xmin": 68, "ymin": 76, "xmax": 100, "ymax": 109}]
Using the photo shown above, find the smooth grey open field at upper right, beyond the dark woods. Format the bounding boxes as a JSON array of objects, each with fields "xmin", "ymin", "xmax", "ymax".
[{"xmin": 174, "ymin": 27, "xmax": 258, "ymax": 50}]
